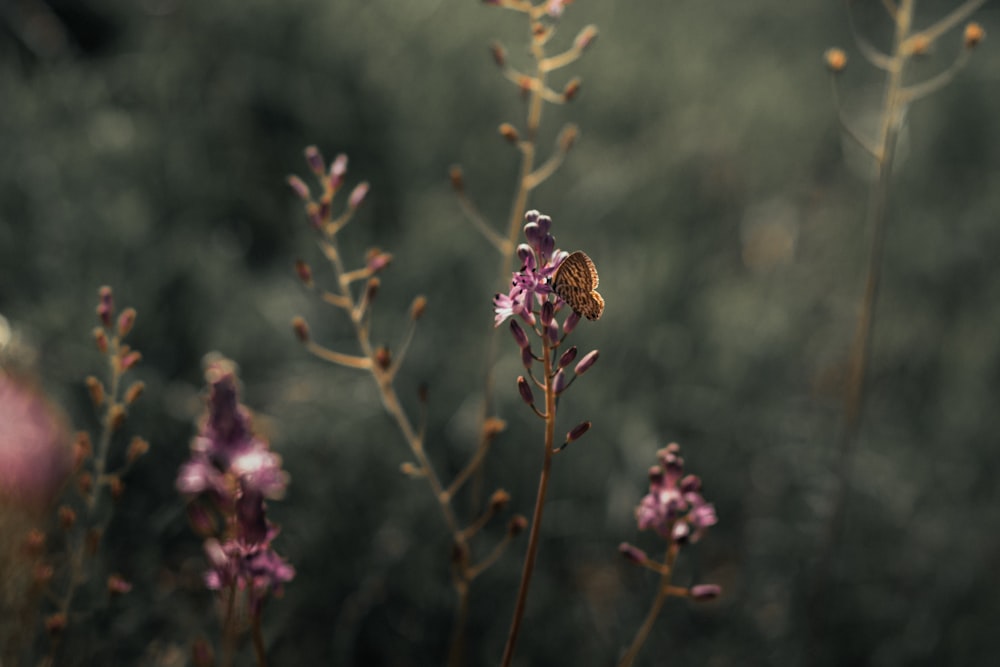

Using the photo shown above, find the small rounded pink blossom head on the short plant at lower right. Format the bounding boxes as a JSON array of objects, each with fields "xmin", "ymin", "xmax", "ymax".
[{"xmin": 635, "ymin": 443, "xmax": 718, "ymax": 544}]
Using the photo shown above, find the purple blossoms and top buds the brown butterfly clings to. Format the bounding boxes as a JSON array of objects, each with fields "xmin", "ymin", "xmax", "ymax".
[{"xmin": 493, "ymin": 211, "xmax": 580, "ymax": 332}]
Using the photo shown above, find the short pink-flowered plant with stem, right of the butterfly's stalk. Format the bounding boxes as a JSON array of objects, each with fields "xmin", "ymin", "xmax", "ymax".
[{"xmin": 618, "ymin": 443, "xmax": 721, "ymax": 667}]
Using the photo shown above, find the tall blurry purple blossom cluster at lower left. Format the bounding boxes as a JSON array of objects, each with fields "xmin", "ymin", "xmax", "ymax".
[{"xmin": 177, "ymin": 360, "xmax": 295, "ymax": 613}]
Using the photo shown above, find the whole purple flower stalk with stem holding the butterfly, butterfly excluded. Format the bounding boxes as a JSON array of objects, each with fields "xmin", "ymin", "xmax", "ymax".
[{"xmin": 493, "ymin": 211, "xmax": 597, "ymax": 667}]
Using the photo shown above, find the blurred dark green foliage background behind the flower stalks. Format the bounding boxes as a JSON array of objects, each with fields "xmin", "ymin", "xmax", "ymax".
[{"xmin": 0, "ymin": 0, "xmax": 1000, "ymax": 666}]
